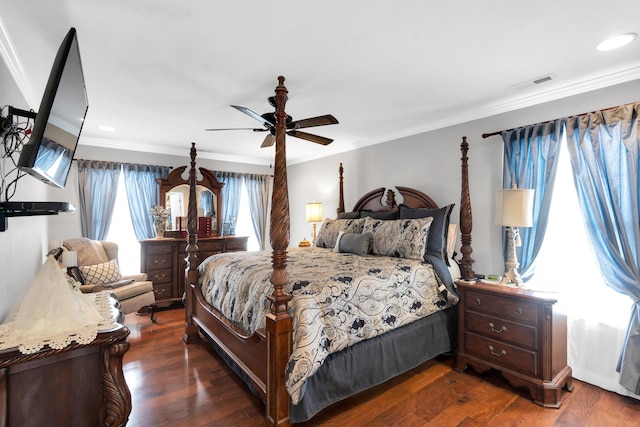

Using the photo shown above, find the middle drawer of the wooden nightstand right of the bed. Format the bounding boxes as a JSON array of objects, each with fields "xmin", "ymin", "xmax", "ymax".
[{"xmin": 464, "ymin": 311, "xmax": 537, "ymax": 350}]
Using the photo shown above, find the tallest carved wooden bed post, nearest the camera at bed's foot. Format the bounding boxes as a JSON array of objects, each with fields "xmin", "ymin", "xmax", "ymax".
[{"xmin": 265, "ymin": 76, "xmax": 292, "ymax": 426}]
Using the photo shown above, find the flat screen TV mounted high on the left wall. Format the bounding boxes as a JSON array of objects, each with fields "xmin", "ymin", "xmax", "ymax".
[{"xmin": 18, "ymin": 28, "xmax": 89, "ymax": 188}]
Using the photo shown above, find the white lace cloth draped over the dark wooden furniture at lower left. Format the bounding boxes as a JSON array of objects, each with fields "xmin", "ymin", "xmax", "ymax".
[{"xmin": 0, "ymin": 255, "xmax": 117, "ymax": 354}]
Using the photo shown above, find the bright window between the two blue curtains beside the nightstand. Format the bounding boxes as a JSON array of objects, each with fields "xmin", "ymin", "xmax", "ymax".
[{"xmin": 527, "ymin": 133, "xmax": 637, "ymax": 398}]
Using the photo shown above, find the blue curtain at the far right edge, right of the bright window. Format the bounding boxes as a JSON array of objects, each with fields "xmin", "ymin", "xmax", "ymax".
[{"xmin": 566, "ymin": 103, "xmax": 640, "ymax": 394}]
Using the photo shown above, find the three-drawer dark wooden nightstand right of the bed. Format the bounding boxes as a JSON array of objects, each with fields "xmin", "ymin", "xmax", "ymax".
[{"xmin": 455, "ymin": 281, "xmax": 573, "ymax": 408}]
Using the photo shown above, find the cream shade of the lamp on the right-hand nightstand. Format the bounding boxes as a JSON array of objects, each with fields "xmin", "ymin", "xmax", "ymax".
[{"xmin": 495, "ymin": 188, "xmax": 535, "ymax": 227}]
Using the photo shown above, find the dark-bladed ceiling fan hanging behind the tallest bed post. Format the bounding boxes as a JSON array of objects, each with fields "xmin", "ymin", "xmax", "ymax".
[{"xmin": 205, "ymin": 96, "xmax": 338, "ymax": 147}]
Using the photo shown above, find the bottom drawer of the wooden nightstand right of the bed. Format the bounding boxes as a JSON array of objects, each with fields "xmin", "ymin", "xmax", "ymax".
[{"xmin": 465, "ymin": 333, "xmax": 538, "ymax": 376}]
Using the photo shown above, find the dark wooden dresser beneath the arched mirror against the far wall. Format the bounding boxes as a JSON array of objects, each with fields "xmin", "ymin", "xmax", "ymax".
[{"xmin": 140, "ymin": 236, "xmax": 249, "ymax": 307}]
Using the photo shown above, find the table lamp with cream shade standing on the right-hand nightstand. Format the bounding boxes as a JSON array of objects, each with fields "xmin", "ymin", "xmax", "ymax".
[{"xmin": 495, "ymin": 185, "xmax": 535, "ymax": 286}]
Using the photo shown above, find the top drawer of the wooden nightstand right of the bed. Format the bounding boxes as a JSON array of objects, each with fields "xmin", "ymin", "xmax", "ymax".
[{"xmin": 464, "ymin": 290, "xmax": 538, "ymax": 325}]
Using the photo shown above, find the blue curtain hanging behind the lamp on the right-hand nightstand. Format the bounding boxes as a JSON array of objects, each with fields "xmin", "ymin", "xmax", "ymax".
[{"xmin": 502, "ymin": 120, "xmax": 562, "ymax": 282}]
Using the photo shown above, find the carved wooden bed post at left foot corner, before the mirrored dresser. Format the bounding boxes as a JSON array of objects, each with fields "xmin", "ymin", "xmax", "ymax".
[{"xmin": 182, "ymin": 142, "xmax": 200, "ymax": 344}]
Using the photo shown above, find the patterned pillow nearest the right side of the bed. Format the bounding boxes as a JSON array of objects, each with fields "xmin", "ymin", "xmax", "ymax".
[{"xmin": 362, "ymin": 217, "xmax": 433, "ymax": 259}]
